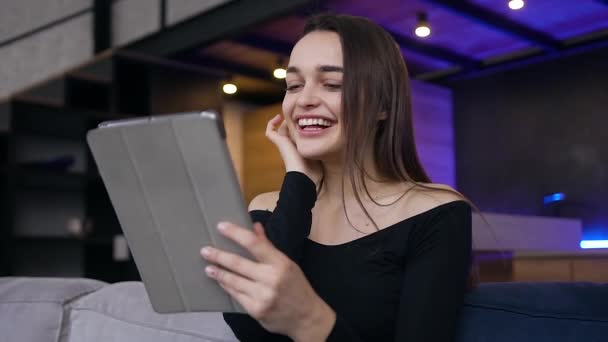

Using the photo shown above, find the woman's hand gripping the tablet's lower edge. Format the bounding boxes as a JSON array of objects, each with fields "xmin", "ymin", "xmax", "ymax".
[{"xmin": 201, "ymin": 223, "xmax": 335, "ymax": 341}]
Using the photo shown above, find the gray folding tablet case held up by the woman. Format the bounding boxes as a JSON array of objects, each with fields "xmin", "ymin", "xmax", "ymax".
[{"xmin": 87, "ymin": 112, "xmax": 252, "ymax": 313}]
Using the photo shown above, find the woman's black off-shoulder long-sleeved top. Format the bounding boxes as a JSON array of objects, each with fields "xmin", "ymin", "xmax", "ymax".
[{"xmin": 224, "ymin": 186, "xmax": 471, "ymax": 342}]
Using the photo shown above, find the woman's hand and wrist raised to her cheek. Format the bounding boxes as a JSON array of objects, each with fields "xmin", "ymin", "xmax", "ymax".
[{"xmin": 266, "ymin": 114, "xmax": 322, "ymax": 185}]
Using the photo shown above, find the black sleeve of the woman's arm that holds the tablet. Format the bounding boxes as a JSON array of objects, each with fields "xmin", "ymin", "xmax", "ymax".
[{"xmin": 327, "ymin": 202, "xmax": 471, "ymax": 342}]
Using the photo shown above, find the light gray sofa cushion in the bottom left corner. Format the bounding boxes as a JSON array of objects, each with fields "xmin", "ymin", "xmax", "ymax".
[{"xmin": 0, "ymin": 278, "xmax": 105, "ymax": 342}]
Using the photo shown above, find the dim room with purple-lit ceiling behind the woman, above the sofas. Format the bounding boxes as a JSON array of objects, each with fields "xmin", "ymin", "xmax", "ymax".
[{"xmin": 0, "ymin": 0, "xmax": 608, "ymax": 282}]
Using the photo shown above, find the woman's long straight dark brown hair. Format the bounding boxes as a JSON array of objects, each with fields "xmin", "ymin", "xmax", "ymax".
[{"xmin": 304, "ymin": 14, "xmax": 478, "ymax": 282}]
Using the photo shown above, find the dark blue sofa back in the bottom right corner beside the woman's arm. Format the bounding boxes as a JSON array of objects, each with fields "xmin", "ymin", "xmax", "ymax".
[{"xmin": 457, "ymin": 282, "xmax": 608, "ymax": 342}]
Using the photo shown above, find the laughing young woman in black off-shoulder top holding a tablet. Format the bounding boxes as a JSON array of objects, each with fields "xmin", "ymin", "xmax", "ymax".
[{"xmin": 201, "ymin": 15, "xmax": 471, "ymax": 342}]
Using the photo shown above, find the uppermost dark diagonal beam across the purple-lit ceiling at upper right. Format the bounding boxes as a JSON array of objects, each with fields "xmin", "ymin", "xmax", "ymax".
[{"xmin": 425, "ymin": 0, "xmax": 563, "ymax": 51}]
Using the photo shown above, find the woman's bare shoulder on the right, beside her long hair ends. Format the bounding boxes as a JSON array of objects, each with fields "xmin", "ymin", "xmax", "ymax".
[{"xmin": 409, "ymin": 183, "xmax": 465, "ymax": 213}]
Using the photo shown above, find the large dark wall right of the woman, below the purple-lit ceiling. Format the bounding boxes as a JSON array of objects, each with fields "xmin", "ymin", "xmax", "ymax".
[{"xmin": 452, "ymin": 49, "xmax": 608, "ymax": 237}]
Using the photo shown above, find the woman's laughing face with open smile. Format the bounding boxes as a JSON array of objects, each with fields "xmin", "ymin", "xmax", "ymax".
[{"xmin": 283, "ymin": 31, "xmax": 344, "ymax": 160}]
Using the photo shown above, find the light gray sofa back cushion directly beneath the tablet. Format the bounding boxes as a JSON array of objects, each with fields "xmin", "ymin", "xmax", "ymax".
[{"xmin": 67, "ymin": 282, "xmax": 238, "ymax": 342}]
